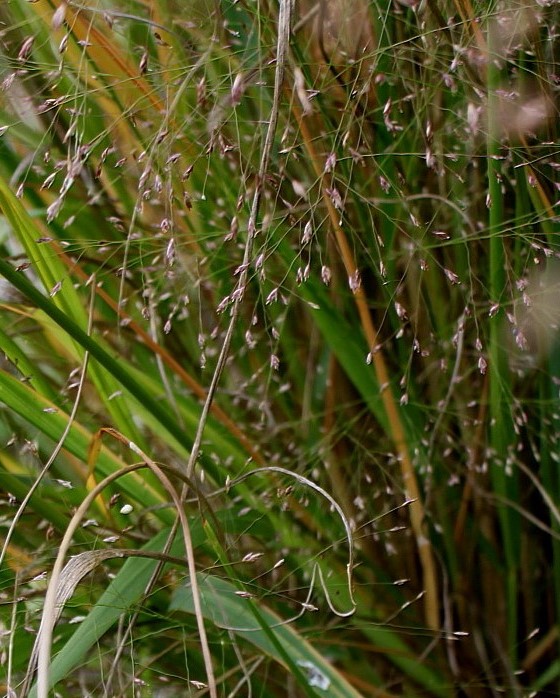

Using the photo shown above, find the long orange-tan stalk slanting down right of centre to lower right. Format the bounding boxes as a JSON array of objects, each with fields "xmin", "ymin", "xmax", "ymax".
[{"xmin": 292, "ymin": 104, "xmax": 440, "ymax": 630}]
